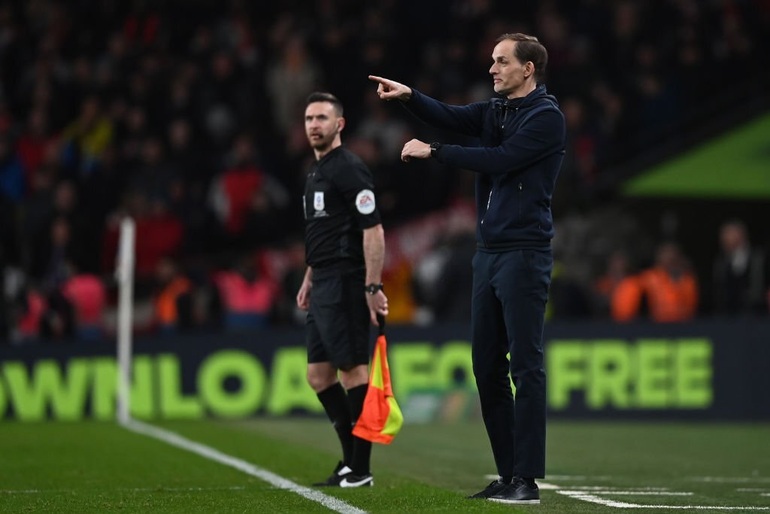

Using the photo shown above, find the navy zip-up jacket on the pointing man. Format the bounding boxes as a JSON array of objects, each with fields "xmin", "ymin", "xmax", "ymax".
[{"xmin": 404, "ymin": 84, "xmax": 567, "ymax": 252}]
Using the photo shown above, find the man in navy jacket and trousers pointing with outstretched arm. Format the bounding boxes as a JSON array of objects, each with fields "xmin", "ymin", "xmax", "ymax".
[{"xmin": 369, "ymin": 34, "xmax": 566, "ymax": 503}]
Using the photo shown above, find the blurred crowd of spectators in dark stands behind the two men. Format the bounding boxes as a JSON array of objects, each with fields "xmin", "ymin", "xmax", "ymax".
[{"xmin": 0, "ymin": 0, "xmax": 770, "ymax": 343}]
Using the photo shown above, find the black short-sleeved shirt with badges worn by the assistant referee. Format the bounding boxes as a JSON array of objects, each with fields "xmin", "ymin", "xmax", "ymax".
[{"xmin": 303, "ymin": 146, "xmax": 380, "ymax": 269}]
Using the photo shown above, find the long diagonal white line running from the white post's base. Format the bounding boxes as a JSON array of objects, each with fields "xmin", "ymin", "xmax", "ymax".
[{"xmin": 120, "ymin": 419, "xmax": 366, "ymax": 514}]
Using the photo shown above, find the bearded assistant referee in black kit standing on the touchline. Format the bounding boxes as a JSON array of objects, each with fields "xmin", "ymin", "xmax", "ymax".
[{"xmin": 297, "ymin": 93, "xmax": 388, "ymax": 487}]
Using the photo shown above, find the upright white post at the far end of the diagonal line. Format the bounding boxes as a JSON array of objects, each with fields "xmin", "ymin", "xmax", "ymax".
[{"xmin": 115, "ymin": 217, "xmax": 136, "ymax": 424}]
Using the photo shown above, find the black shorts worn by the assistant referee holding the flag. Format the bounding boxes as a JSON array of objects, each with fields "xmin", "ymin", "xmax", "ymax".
[{"xmin": 306, "ymin": 269, "xmax": 371, "ymax": 370}]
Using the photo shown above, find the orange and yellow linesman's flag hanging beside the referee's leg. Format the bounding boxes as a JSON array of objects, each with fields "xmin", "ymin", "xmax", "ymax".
[{"xmin": 353, "ymin": 316, "xmax": 404, "ymax": 444}]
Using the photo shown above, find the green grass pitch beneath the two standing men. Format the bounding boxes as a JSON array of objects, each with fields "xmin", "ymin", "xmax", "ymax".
[{"xmin": 0, "ymin": 418, "xmax": 770, "ymax": 514}]
